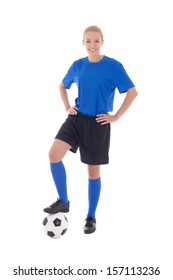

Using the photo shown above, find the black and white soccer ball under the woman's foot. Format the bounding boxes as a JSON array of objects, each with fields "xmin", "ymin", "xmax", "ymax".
[{"xmin": 43, "ymin": 212, "xmax": 68, "ymax": 239}]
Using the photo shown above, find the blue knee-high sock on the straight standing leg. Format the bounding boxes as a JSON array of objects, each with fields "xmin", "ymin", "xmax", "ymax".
[{"xmin": 87, "ymin": 178, "xmax": 101, "ymax": 219}]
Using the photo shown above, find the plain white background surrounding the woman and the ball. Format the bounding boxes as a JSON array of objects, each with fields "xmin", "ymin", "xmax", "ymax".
[{"xmin": 0, "ymin": 0, "xmax": 173, "ymax": 280}]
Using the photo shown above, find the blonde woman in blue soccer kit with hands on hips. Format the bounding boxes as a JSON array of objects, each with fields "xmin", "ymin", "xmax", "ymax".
[{"xmin": 44, "ymin": 26, "xmax": 137, "ymax": 234}]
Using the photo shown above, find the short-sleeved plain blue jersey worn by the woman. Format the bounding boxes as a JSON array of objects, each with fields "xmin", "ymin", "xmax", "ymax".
[{"xmin": 62, "ymin": 56, "xmax": 134, "ymax": 116}]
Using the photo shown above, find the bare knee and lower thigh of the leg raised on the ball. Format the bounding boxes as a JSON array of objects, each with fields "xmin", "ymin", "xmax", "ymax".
[{"xmin": 49, "ymin": 139, "xmax": 71, "ymax": 163}]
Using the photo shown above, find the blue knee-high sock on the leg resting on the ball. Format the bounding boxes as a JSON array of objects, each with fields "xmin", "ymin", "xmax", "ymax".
[{"xmin": 50, "ymin": 161, "xmax": 68, "ymax": 204}]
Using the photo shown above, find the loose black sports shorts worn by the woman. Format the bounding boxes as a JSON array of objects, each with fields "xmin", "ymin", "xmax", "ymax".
[{"xmin": 55, "ymin": 112, "xmax": 110, "ymax": 165}]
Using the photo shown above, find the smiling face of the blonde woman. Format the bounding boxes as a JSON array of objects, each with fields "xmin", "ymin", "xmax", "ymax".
[{"xmin": 83, "ymin": 31, "xmax": 103, "ymax": 57}]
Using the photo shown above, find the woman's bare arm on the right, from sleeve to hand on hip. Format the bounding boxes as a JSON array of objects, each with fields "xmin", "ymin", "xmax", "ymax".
[{"xmin": 96, "ymin": 87, "xmax": 137, "ymax": 124}]
